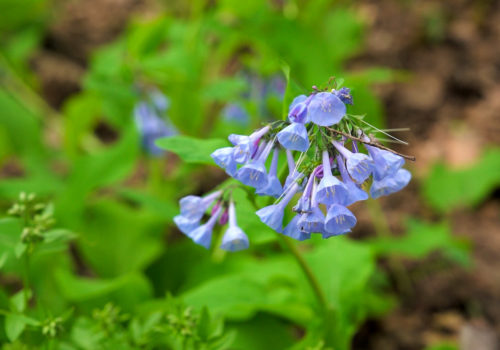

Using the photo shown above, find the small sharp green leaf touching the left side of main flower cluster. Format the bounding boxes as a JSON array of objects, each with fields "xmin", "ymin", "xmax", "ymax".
[{"xmin": 156, "ymin": 135, "xmax": 228, "ymax": 164}]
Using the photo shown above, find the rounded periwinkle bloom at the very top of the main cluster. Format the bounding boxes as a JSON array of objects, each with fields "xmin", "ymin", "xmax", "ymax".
[{"xmin": 307, "ymin": 92, "xmax": 346, "ymax": 126}]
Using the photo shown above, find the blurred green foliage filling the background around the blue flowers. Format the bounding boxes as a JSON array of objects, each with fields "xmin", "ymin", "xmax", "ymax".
[{"xmin": 0, "ymin": 0, "xmax": 500, "ymax": 350}]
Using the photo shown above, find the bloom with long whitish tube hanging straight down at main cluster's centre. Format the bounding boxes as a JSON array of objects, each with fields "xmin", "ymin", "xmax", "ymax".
[{"xmin": 316, "ymin": 150, "xmax": 348, "ymax": 205}]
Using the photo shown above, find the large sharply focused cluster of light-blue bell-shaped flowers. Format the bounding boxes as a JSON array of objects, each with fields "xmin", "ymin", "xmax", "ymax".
[{"xmin": 175, "ymin": 88, "xmax": 411, "ymax": 250}]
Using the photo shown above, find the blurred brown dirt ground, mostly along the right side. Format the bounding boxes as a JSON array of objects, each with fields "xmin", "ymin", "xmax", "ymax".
[{"xmin": 33, "ymin": 0, "xmax": 500, "ymax": 350}]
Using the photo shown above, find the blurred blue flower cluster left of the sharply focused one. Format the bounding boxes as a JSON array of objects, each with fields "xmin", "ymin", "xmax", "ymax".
[{"xmin": 134, "ymin": 90, "xmax": 177, "ymax": 156}]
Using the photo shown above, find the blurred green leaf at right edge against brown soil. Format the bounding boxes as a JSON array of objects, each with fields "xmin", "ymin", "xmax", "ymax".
[{"xmin": 423, "ymin": 148, "xmax": 500, "ymax": 212}]
